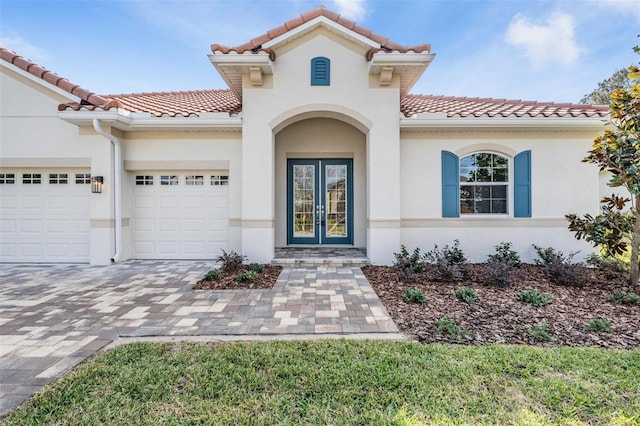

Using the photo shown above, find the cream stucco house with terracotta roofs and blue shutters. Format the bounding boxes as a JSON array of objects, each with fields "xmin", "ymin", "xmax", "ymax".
[{"xmin": 0, "ymin": 7, "xmax": 608, "ymax": 265}]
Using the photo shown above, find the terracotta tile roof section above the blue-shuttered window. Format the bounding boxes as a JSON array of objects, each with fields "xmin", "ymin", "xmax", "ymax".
[{"xmin": 400, "ymin": 95, "xmax": 609, "ymax": 117}]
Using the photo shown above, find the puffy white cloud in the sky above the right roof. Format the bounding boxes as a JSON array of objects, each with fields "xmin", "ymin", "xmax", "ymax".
[{"xmin": 505, "ymin": 12, "xmax": 582, "ymax": 68}]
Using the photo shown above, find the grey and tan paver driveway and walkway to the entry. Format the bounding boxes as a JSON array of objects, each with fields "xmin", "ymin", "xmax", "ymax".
[{"xmin": 0, "ymin": 261, "xmax": 402, "ymax": 417}]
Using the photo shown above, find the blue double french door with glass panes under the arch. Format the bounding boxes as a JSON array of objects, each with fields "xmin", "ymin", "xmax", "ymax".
[{"xmin": 287, "ymin": 158, "xmax": 353, "ymax": 244}]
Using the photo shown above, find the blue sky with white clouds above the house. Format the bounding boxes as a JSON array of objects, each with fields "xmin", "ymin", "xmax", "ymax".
[{"xmin": 0, "ymin": 0, "xmax": 640, "ymax": 103}]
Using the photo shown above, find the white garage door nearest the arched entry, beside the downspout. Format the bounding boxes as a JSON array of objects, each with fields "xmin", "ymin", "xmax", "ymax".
[{"xmin": 132, "ymin": 172, "xmax": 229, "ymax": 259}]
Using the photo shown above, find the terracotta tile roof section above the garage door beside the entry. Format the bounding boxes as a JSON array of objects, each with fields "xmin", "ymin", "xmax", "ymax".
[{"xmin": 58, "ymin": 90, "xmax": 242, "ymax": 117}]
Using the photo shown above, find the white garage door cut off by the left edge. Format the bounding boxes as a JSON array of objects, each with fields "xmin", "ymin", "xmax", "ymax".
[{"xmin": 0, "ymin": 169, "xmax": 91, "ymax": 263}]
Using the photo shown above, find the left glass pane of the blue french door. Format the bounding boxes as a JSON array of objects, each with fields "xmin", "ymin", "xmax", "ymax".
[{"xmin": 293, "ymin": 164, "xmax": 316, "ymax": 237}]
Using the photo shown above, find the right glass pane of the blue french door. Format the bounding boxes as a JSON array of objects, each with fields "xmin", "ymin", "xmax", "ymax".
[{"xmin": 325, "ymin": 164, "xmax": 348, "ymax": 238}]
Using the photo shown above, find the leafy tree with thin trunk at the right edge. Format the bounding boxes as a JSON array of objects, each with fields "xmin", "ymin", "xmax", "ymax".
[{"xmin": 565, "ymin": 46, "xmax": 640, "ymax": 286}]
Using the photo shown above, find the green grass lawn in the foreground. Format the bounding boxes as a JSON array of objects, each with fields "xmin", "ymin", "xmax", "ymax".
[{"xmin": 2, "ymin": 340, "xmax": 640, "ymax": 425}]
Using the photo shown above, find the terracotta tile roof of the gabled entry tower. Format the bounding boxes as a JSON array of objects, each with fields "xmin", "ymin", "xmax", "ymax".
[{"xmin": 211, "ymin": 6, "xmax": 431, "ymax": 61}]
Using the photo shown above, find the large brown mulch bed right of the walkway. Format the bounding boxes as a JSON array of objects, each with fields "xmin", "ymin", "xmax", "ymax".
[{"xmin": 363, "ymin": 265, "xmax": 640, "ymax": 349}]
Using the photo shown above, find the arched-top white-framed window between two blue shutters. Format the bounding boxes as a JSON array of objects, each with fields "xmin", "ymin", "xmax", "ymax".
[{"xmin": 460, "ymin": 152, "xmax": 509, "ymax": 214}]
